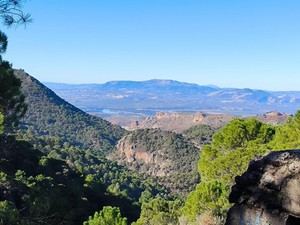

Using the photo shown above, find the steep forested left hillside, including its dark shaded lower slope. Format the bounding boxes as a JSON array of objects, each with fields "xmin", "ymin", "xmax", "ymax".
[{"xmin": 0, "ymin": 71, "xmax": 170, "ymax": 225}]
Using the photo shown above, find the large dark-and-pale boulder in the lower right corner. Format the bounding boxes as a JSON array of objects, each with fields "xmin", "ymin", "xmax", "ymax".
[{"xmin": 226, "ymin": 150, "xmax": 300, "ymax": 225}]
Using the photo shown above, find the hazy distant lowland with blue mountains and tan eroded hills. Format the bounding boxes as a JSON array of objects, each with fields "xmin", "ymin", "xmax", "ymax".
[{"xmin": 45, "ymin": 80, "xmax": 292, "ymax": 133}]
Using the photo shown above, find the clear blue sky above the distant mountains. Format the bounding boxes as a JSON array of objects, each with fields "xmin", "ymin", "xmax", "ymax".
[{"xmin": 2, "ymin": 0, "xmax": 300, "ymax": 90}]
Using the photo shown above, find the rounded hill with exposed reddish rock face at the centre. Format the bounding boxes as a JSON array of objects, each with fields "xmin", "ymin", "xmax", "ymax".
[{"xmin": 110, "ymin": 129, "xmax": 199, "ymax": 195}]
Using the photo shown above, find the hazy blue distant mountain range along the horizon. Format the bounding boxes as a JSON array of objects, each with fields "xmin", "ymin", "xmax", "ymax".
[{"xmin": 45, "ymin": 80, "xmax": 300, "ymax": 115}]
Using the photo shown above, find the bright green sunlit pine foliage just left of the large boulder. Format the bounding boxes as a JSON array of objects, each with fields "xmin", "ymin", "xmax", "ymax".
[{"xmin": 183, "ymin": 118, "xmax": 275, "ymax": 220}]
